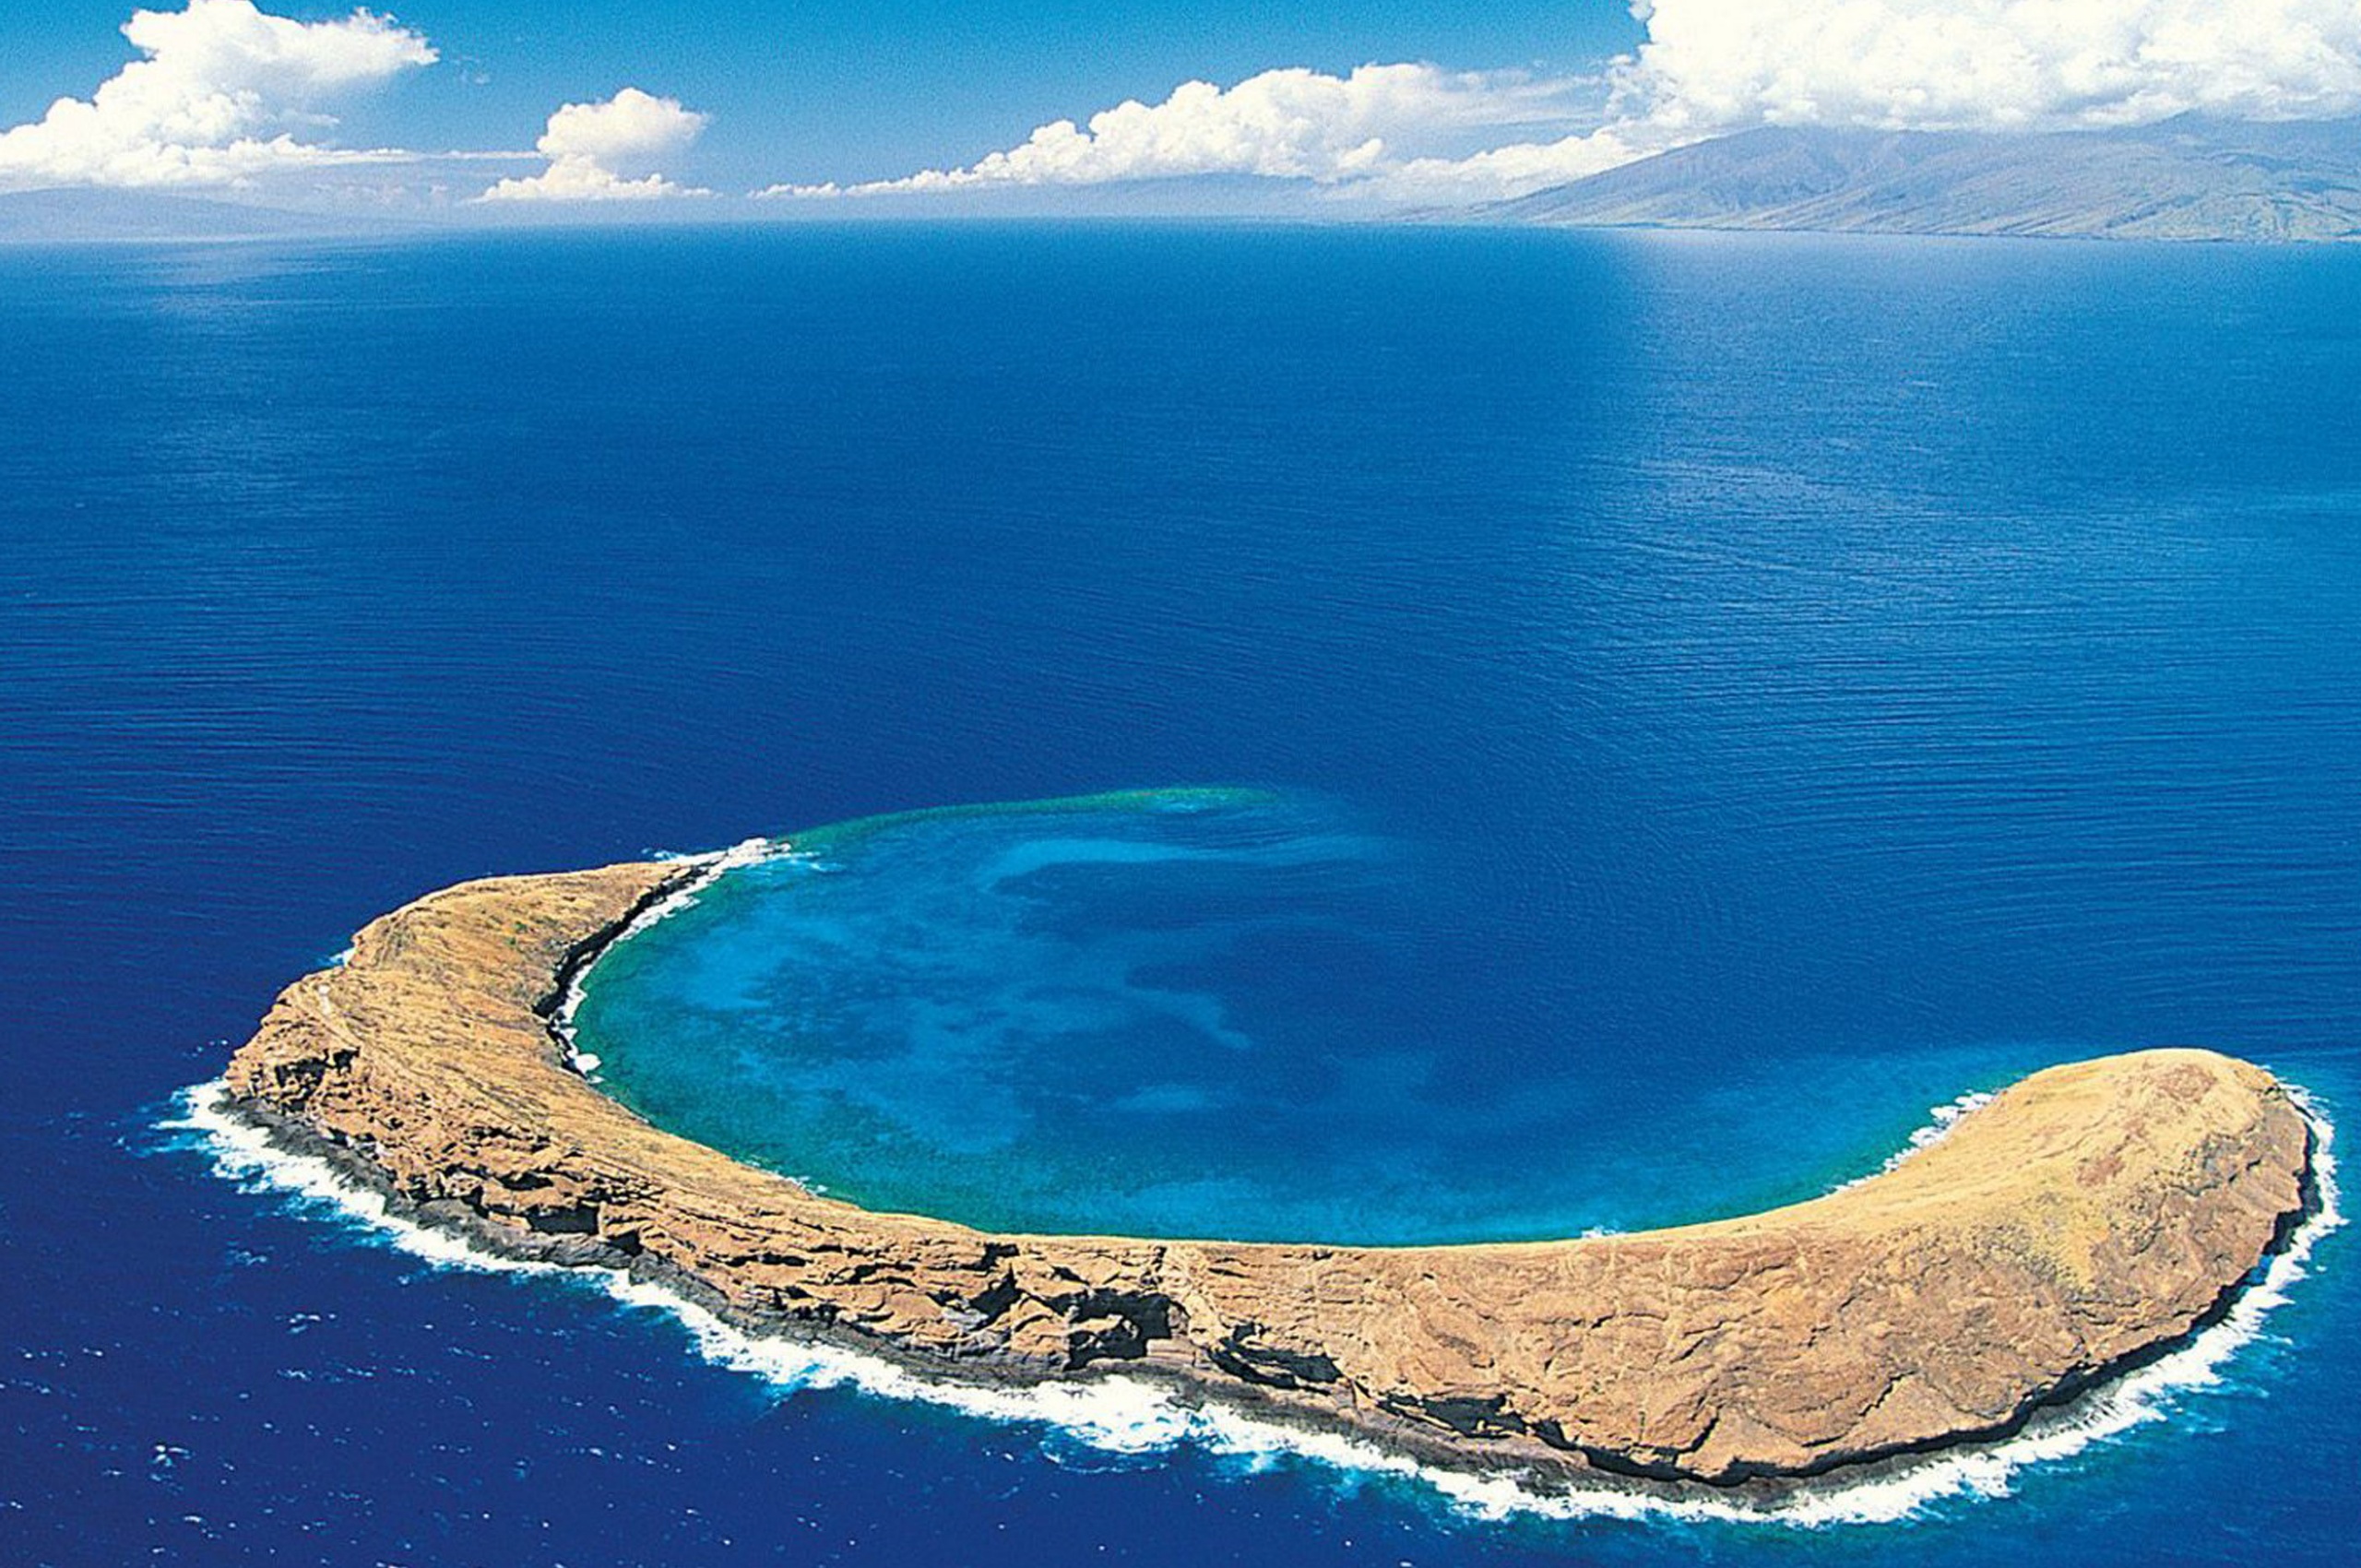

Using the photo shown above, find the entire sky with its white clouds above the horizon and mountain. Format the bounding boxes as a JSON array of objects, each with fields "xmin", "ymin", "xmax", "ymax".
[{"xmin": 0, "ymin": 0, "xmax": 2361, "ymax": 215}]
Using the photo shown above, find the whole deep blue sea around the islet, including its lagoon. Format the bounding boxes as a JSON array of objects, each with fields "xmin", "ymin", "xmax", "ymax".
[{"xmin": 0, "ymin": 224, "xmax": 2361, "ymax": 1568}]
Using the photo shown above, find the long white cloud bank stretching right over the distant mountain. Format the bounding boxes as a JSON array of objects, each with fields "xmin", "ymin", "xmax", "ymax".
[{"xmin": 783, "ymin": 0, "xmax": 2361, "ymax": 201}]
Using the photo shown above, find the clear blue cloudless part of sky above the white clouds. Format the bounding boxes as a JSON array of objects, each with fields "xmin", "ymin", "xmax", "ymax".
[{"xmin": 0, "ymin": 0, "xmax": 1641, "ymax": 189}]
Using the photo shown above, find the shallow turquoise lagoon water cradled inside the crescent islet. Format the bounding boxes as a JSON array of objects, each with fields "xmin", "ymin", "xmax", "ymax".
[{"xmin": 576, "ymin": 789, "xmax": 2045, "ymax": 1242}]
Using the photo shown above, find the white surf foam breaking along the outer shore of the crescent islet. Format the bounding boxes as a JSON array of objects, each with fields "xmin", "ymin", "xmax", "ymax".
[{"xmin": 160, "ymin": 1072, "xmax": 2344, "ymax": 1527}]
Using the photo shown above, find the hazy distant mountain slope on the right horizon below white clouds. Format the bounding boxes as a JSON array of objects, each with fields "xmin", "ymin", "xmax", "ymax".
[{"xmin": 1478, "ymin": 115, "xmax": 2361, "ymax": 241}]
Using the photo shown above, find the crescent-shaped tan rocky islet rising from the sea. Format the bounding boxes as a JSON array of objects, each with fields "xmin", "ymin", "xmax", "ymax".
[{"xmin": 229, "ymin": 864, "xmax": 2311, "ymax": 1483}]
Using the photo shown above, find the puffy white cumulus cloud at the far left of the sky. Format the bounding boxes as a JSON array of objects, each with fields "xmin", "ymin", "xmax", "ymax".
[{"xmin": 0, "ymin": 0, "xmax": 434, "ymax": 189}]
